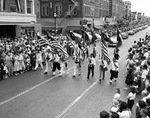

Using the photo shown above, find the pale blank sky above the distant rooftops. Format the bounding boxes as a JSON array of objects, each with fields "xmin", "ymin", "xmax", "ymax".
[{"xmin": 124, "ymin": 0, "xmax": 150, "ymax": 16}]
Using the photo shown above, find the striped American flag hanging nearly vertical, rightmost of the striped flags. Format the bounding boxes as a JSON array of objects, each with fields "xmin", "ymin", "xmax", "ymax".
[{"xmin": 101, "ymin": 33, "xmax": 111, "ymax": 64}]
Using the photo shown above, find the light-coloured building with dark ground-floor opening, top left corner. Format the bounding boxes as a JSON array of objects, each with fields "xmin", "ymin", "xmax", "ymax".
[{"xmin": 0, "ymin": 0, "xmax": 36, "ymax": 38}]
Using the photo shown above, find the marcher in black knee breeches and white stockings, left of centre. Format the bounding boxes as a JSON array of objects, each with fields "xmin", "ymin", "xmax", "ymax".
[{"xmin": 52, "ymin": 54, "xmax": 62, "ymax": 76}]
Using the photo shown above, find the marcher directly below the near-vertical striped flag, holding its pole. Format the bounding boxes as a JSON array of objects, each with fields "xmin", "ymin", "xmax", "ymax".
[{"xmin": 99, "ymin": 59, "xmax": 108, "ymax": 82}]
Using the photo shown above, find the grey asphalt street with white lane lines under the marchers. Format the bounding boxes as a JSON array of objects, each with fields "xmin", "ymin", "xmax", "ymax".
[{"xmin": 0, "ymin": 27, "xmax": 150, "ymax": 118}]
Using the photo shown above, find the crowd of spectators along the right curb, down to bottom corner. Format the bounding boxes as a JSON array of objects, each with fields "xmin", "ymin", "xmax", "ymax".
[{"xmin": 100, "ymin": 35, "xmax": 150, "ymax": 118}]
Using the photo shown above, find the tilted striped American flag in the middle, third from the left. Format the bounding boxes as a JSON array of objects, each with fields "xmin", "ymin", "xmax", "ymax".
[{"xmin": 66, "ymin": 34, "xmax": 80, "ymax": 57}]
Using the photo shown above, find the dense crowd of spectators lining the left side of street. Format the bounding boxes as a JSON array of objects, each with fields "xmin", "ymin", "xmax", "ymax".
[{"xmin": 0, "ymin": 36, "xmax": 71, "ymax": 80}]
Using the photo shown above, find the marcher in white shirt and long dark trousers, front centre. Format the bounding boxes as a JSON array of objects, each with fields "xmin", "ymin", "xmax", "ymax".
[{"xmin": 87, "ymin": 54, "xmax": 96, "ymax": 80}]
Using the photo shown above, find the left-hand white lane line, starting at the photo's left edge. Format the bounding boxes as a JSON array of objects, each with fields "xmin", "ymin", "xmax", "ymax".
[{"xmin": 0, "ymin": 66, "xmax": 74, "ymax": 106}]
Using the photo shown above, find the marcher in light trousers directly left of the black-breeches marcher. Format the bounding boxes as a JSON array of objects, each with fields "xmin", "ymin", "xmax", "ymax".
[{"xmin": 44, "ymin": 49, "xmax": 53, "ymax": 74}]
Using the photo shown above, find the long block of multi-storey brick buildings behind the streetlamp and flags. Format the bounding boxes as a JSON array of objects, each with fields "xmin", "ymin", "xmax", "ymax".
[{"xmin": 35, "ymin": 0, "xmax": 124, "ymax": 33}]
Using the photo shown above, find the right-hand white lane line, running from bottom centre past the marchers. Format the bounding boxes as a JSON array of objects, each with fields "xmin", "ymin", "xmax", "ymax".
[{"xmin": 55, "ymin": 53, "xmax": 127, "ymax": 118}]
